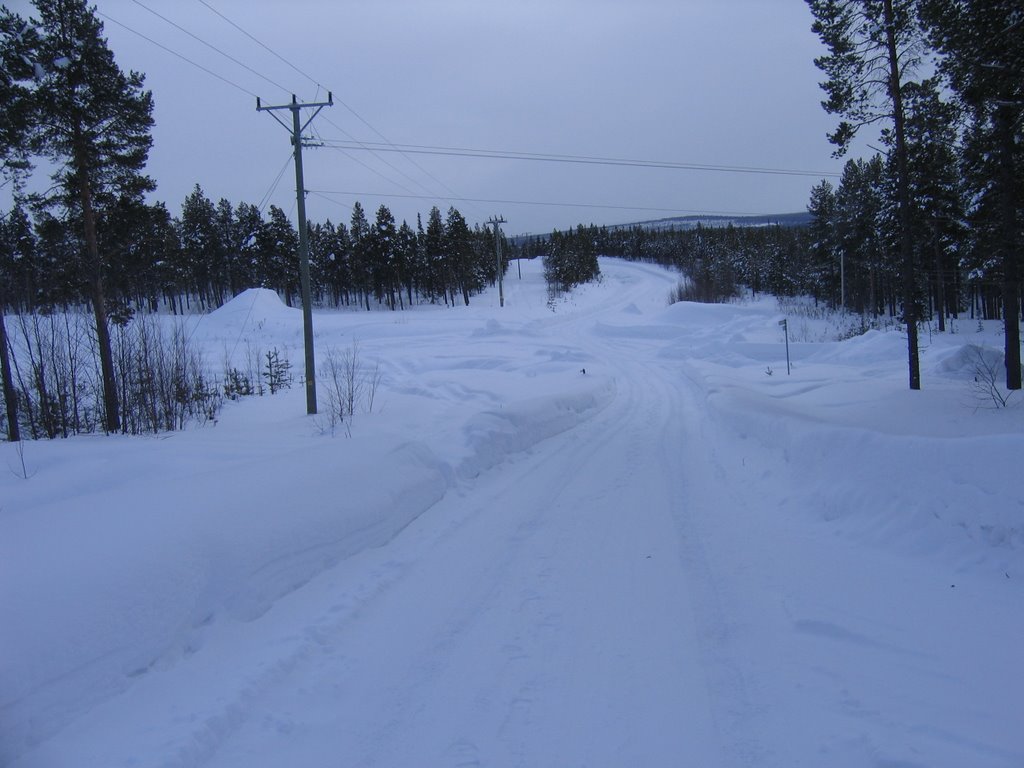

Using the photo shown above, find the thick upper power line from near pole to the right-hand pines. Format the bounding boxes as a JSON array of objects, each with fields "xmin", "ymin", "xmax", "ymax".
[{"xmin": 317, "ymin": 141, "xmax": 841, "ymax": 178}]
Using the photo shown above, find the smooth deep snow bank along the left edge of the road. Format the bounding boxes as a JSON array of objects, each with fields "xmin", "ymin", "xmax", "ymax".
[{"xmin": 0, "ymin": 385, "xmax": 610, "ymax": 762}]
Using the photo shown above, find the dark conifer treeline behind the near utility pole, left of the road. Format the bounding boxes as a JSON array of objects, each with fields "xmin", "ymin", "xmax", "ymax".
[{"xmin": 0, "ymin": 185, "xmax": 507, "ymax": 322}]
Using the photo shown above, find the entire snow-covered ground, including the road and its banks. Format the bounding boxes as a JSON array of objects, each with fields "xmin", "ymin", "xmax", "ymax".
[{"xmin": 0, "ymin": 260, "xmax": 1024, "ymax": 768}]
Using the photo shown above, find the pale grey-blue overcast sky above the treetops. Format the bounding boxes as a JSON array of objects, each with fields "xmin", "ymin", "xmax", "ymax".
[{"xmin": 12, "ymin": 0, "xmax": 860, "ymax": 234}]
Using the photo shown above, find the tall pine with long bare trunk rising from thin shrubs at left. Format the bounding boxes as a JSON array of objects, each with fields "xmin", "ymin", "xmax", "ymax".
[{"xmin": 34, "ymin": 0, "xmax": 155, "ymax": 432}]
